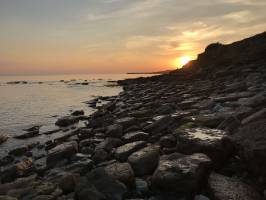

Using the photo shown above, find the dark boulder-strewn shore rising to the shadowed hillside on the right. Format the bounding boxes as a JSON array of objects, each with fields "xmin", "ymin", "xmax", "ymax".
[{"xmin": 0, "ymin": 33, "xmax": 266, "ymax": 200}]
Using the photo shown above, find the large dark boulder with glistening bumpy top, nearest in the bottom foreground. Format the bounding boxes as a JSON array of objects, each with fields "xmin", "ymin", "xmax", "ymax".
[{"xmin": 151, "ymin": 154, "xmax": 211, "ymax": 195}]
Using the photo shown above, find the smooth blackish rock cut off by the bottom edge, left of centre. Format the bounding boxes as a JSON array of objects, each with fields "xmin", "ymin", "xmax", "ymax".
[{"xmin": 87, "ymin": 168, "xmax": 127, "ymax": 200}]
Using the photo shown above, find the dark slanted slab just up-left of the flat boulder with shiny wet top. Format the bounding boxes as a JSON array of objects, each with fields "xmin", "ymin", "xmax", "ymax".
[{"xmin": 143, "ymin": 115, "xmax": 174, "ymax": 134}]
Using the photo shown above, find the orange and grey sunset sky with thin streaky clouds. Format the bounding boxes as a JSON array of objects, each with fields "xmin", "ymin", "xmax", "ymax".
[{"xmin": 0, "ymin": 0, "xmax": 266, "ymax": 75}]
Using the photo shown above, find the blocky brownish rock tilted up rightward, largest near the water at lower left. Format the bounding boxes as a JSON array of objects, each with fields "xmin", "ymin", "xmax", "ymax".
[{"xmin": 46, "ymin": 141, "xmax": 78, "ymax": 167}]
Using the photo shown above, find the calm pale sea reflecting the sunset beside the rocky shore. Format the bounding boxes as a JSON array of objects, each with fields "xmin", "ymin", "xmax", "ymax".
[{"xmin": 0, "ymin": 74, "xmax": 152, "ymax": 154}]
